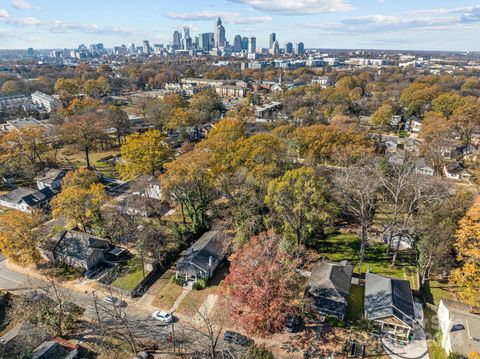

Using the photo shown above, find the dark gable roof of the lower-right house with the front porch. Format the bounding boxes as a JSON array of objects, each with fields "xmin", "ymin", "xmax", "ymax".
[{"xmin": 365, "ymin": 273, "xmax": 415, "ymax": 328}]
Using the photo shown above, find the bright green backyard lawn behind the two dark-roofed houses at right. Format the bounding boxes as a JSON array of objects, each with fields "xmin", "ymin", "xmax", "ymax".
[{"xmin": 318, "ymin": 233, "xmax": 418, "ymax": 289}]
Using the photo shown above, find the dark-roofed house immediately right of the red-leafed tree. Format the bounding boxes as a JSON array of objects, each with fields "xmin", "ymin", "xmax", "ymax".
[{"xmin": 304, "ymin": 260, "xmax": 353, "ymax": 320}]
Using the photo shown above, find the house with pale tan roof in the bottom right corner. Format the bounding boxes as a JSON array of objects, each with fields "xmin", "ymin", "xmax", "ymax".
[{"xmin": 437, "ymin": 299, "xmax": 480, "ymax": 357}]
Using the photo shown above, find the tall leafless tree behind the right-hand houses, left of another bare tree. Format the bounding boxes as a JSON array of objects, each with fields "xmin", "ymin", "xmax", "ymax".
[{"xmin": 333, "ymin": 157, "xmax": 380, "ymax": 268}]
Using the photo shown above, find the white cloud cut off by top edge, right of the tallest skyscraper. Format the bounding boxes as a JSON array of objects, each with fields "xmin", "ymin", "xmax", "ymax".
[{"xmin": 230, "ymin": 0, "xmax": 354, "ymax": 15}]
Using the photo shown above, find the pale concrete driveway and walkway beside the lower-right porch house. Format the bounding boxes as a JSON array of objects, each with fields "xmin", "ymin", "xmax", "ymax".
[{"xmin": 382, "ymin": 302, "xmax": 430, "ymax": 359}]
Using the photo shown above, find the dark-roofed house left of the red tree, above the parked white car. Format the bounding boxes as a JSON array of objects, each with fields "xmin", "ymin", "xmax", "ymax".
[{"xmin": 175, "ymin": 231, "xmax": 229, "ymax": 282}]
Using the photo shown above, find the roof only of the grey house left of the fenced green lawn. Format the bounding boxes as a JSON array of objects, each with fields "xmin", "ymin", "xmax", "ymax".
[{"xmin": 53, "ymin": 231, "xmax": 109, "ymax": 260}]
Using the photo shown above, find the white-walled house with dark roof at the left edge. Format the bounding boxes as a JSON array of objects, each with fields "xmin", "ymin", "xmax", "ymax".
[{"xmin": 0, "ymin": 187, "xmax": 55, "ymax": 213}]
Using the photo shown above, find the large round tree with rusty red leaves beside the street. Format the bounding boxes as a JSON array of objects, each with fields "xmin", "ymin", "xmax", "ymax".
[{"xmin": 224, "ymin": 232, "xmax": 300, "ymax": 335}]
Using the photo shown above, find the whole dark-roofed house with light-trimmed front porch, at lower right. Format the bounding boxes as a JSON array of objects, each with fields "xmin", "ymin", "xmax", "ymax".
[{"xmin": 364, "ymin": 273, "xmax": 415, "ymax": 341}]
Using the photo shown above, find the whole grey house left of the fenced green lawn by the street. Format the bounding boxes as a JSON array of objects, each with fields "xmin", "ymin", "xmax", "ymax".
[{"xmin": 52, "ymin": 231, "xmax": 111, "ymax": 270}]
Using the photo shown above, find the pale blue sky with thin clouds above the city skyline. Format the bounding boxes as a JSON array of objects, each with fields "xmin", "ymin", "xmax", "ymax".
[{"xmin": 0, "ymin": 0, "xmax": 480, "ymax": 51}]
